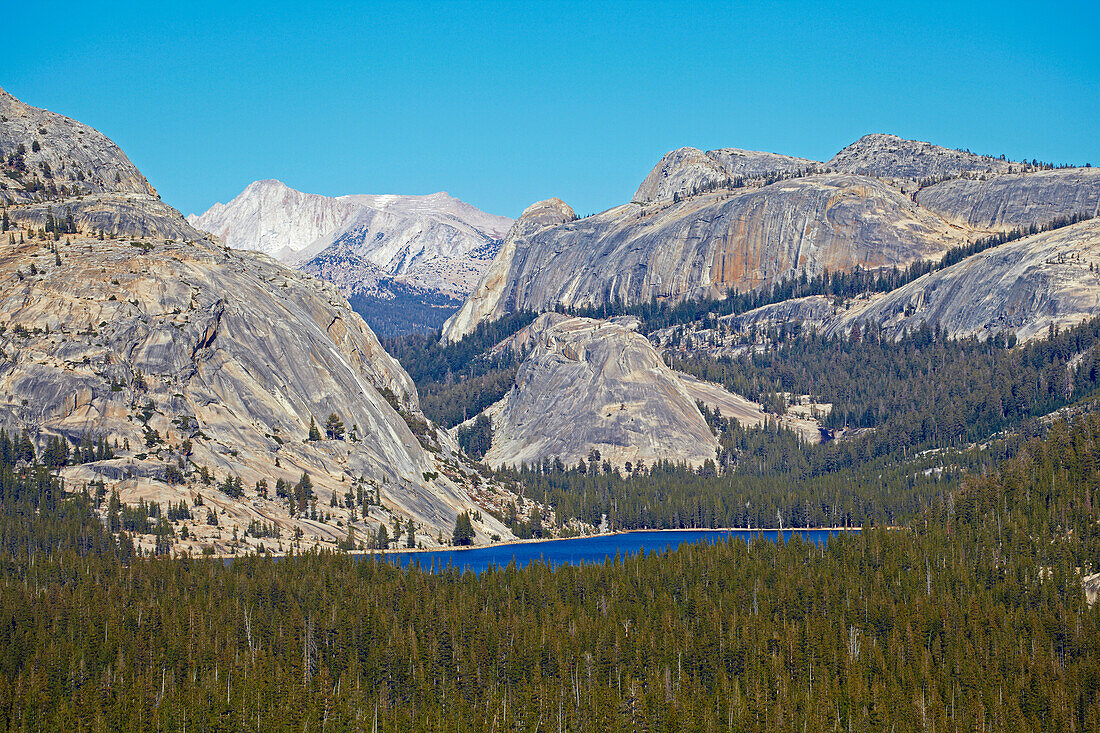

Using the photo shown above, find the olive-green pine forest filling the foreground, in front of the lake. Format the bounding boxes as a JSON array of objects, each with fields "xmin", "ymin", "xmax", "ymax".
[{"xmin": 0, "ymin": 407, "xmax": 1100, "ymax": 731}]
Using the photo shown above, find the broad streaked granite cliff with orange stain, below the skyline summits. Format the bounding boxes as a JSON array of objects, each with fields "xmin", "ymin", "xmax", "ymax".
[{"xmin": 444, "ymin": 175, "xmax": 969, "ymax": 341}]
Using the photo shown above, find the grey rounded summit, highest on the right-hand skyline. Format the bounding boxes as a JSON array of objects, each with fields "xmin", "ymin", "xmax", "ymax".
[{"xmin": 825, "ymin": 133, "xmax": 1012, "ymax": 180}]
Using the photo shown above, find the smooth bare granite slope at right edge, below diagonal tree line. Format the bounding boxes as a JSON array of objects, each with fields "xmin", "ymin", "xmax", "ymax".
[{"xmin": 831, "ymin": 219, "xmax": 1100, "ymax": 341}]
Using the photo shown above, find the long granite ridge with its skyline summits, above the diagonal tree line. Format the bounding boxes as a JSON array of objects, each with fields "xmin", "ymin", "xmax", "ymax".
[{"xmin": 443, "ymin": 134, "xmax": 1100, "ymax": 341}]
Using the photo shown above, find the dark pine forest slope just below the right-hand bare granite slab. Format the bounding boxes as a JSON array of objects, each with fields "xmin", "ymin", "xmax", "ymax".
[{"xmin": 672, "ymin": 319, "xmax": 1100, "ymax": 456}]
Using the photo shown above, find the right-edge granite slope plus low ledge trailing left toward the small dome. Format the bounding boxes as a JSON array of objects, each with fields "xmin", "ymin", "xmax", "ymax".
[{"xmin": 664, "ymin": 219, "xmax": 1100, "ymax": 347}]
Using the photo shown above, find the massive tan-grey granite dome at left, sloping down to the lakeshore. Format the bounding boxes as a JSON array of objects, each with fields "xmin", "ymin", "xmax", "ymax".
[{"xmin": 0, "ymin": 88, "xmax": 509, "ymax": 545}]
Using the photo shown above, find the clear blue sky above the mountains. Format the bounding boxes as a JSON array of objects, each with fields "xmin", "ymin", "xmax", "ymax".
[{"xmin": 0, "ymin": 0, "xmax": 1100, "ymax": 217}]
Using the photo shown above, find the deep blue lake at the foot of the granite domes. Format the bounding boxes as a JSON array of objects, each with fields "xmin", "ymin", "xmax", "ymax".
[{"xmin": 376, "ymin": 529, "xmax": 843, "ymax": 572}]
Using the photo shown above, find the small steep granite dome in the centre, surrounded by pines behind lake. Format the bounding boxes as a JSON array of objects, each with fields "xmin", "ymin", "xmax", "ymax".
[{"xmin": 475, "ymin": 314, "xmax": 717, "ymax": 466}]
